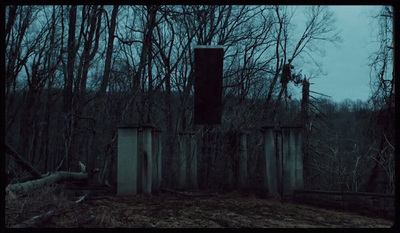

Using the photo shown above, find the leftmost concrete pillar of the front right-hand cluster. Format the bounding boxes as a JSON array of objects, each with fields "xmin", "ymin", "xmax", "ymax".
[{"xmin": 262, "ymin": 126, "xmax": 279, "ymax": 197}]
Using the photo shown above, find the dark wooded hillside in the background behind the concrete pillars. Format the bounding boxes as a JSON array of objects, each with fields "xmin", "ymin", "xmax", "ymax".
[{"xmin": 6, "ymin": 87, "xmax": 394, "ymax": 193}]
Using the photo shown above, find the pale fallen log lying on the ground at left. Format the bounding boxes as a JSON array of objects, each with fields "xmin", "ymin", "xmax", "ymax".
[{"xmin": 6, "ymin": 171, "xmax": 88, "ymax": 196}]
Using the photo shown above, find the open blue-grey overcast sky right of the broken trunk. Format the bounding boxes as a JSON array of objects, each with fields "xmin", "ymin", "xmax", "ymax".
[{"xmin": 291, "ymin": 6, "xmax": 381, "ymax": 102}]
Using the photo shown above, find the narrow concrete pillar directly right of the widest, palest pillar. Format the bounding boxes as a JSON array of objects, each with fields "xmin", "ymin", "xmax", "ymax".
[{"xmin": 142, "ymin": 124, "xmax": 154, "ymax": 195}]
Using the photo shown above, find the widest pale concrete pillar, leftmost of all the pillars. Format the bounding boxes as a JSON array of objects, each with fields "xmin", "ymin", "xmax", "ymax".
[{"xmin": 117, "ymin": 125, "xmax": 138, "ymax": 196}]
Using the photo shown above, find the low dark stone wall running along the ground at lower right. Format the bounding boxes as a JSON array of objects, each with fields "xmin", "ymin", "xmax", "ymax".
[{"xmin": 293, "ymin": 190, "xmax": 395, "ymax": 220}]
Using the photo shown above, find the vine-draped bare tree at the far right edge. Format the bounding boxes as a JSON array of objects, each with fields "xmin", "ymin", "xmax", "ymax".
[{"xmin": 368, "ymin": 6, "xmax": 395, "ymax": 192}]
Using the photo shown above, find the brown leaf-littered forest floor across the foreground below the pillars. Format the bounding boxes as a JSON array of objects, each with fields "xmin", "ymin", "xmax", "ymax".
[{"xmin": 5, "ymin": 185, "xmax": 393, "ymax": 228}]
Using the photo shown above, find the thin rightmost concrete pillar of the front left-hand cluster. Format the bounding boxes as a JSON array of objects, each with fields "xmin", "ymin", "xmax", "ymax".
[{"xmin": 152, "ymin": 128, "xmax": 162, "ymax": 192}]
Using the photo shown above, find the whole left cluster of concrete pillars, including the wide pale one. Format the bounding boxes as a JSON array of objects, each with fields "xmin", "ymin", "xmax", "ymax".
[{"xmin": 117, "ymin": 123, "xmax": 162, "ymax": 195}]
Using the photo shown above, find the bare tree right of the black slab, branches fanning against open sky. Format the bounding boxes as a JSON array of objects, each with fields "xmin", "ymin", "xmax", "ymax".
[{"xmin": 266, "ymin": 6, "xmax": 341, "ymax": 119}]
